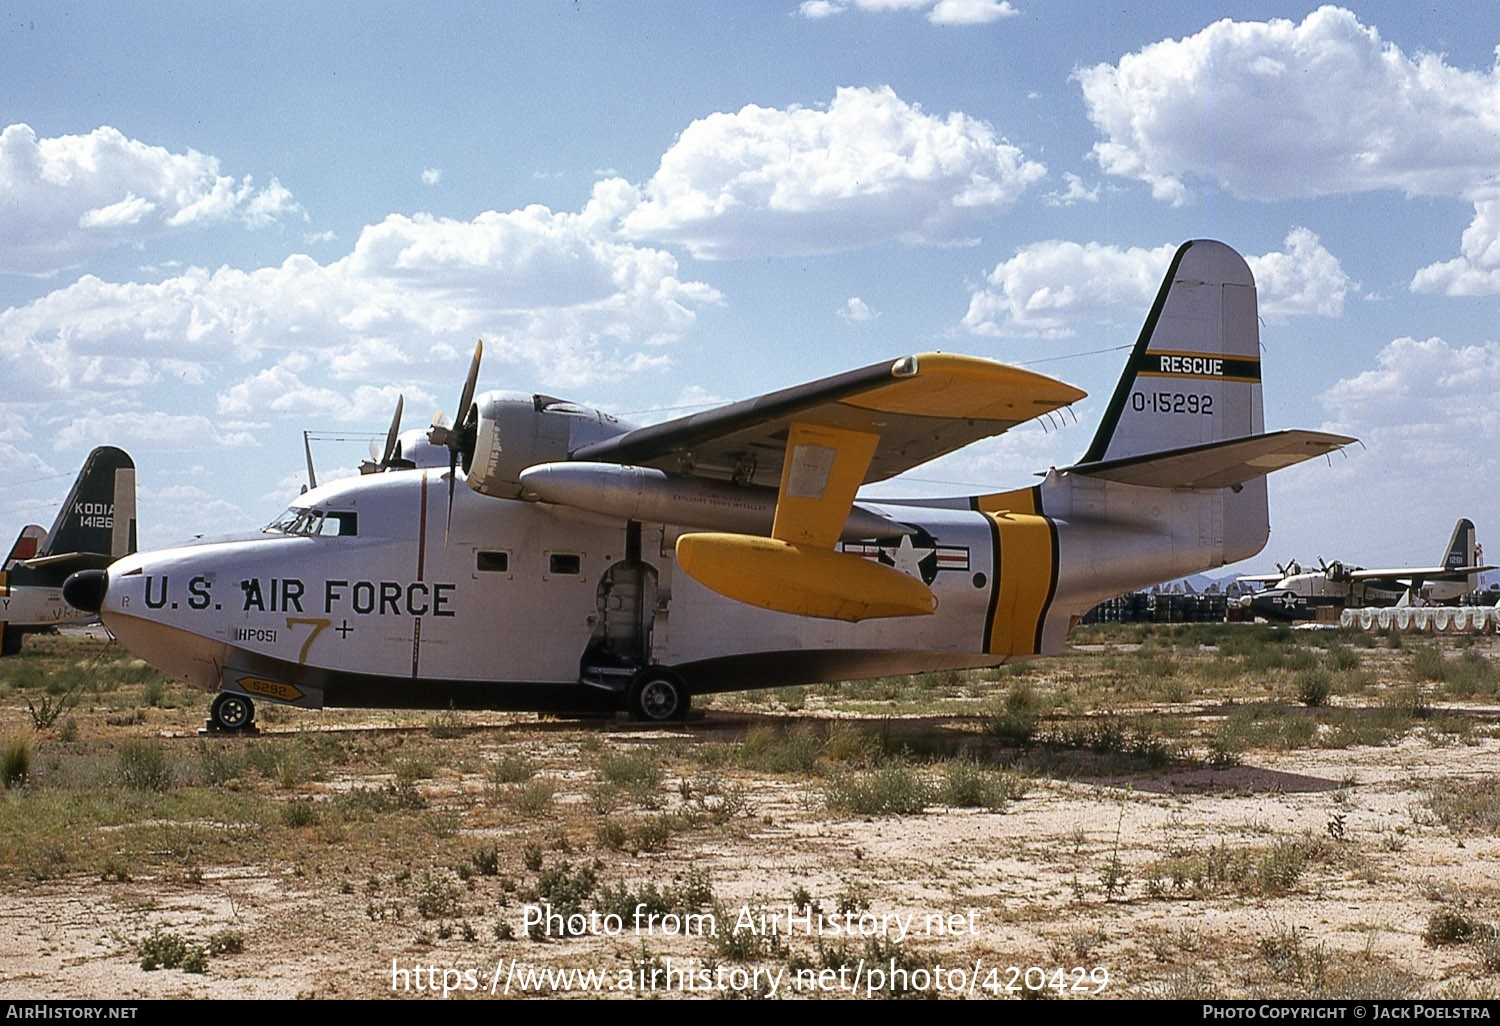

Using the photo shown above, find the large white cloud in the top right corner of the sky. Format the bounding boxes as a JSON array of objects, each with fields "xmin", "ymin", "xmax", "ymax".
[{"xmin": 1076, "ymin": 6, "xmax": 1500, "ymax": 203}]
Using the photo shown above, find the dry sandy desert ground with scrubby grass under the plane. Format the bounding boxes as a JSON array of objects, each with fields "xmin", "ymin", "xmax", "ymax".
[{"xmin": 0, "ymin": 624, "xmax": 1500, "ymax": 1001}]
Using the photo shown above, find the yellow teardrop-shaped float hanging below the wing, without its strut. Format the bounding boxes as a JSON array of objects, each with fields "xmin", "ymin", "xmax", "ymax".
[{"xmin": 677, "ymin": 534, "xmax": 938, "ymax": 623}]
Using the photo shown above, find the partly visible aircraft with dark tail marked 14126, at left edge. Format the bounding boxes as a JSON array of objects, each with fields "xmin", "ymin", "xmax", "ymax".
[{"xmin": 0, "ymin": 446, "xmax": 135, "ymax": 656}]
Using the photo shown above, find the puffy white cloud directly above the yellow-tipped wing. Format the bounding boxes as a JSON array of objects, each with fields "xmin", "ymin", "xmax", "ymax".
[{"xmin": 621, "ymin": 87, "xmax": 1046, "ymax": 258}]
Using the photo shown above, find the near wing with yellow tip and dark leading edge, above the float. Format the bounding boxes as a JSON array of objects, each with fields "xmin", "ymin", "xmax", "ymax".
[{"xmin": 572, "ymin": 353, "xmax": 1086, "ymax": 486}]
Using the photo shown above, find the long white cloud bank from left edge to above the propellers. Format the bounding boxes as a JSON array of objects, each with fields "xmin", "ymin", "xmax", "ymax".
[{"xmin": 0, "ymin": 183, "xmax": 720, "ymax": 405}]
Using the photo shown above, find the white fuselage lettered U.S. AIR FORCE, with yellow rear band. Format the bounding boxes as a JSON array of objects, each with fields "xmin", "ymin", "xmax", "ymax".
[{"xmin": 87, "ymin": 470, "xmax": 1223, "ymax": 710}]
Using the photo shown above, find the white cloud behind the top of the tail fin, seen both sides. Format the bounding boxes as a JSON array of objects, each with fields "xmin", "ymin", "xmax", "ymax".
[{"xmin": 963, "ymin": 228, "xmax": 1355, "ymax": 338}]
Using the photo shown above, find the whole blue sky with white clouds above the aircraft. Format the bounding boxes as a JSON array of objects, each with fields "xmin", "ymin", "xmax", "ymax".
[{"xmin": 0, "ymin": 0, "xmax": 1500, "ymax": 572}]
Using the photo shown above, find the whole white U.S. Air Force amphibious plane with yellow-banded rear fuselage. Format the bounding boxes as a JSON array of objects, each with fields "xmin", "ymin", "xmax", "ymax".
[{"xmin": 68, "ymin": 242, "xmax": 1353, "ymax": 729}]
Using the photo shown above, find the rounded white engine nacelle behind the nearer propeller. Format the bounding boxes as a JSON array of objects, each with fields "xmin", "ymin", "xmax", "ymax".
[{"xmin": 465, "ymin": 392, "xmax": 630, "ymax": 498}]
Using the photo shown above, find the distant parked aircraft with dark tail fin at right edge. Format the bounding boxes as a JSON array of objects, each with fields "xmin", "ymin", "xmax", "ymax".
[{"xmin": 1241, "ymin": 518, "xmax": 1494, "ymax": 621}]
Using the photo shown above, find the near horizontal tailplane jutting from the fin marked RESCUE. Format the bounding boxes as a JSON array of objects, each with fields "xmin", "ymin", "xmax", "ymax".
[{"xmin": 1062, "ymin": 431, "xmax": 1355, "ymax": 489}]
